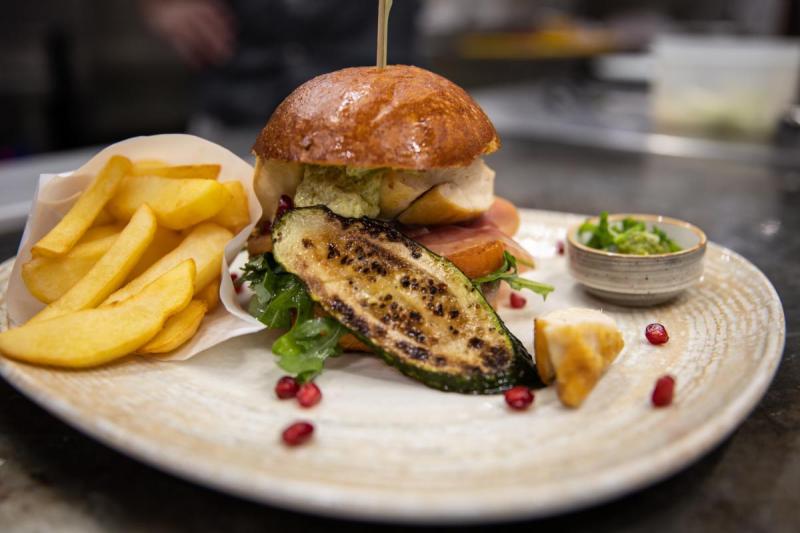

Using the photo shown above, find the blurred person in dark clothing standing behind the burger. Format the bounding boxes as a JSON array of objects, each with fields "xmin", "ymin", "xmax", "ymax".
[{"xmin": 139, "ymin": 0, "xmax": 420, "ymax": 151}]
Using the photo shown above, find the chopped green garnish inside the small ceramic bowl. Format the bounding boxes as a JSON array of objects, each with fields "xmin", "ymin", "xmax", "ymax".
[{"xmin": 578, "ymin": 211, "xmax": 681, "ymax": 255}]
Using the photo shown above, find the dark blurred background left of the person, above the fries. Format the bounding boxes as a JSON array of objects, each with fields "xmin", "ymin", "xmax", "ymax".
[{"xmin": 0, "ymin": 0, "xmax": 190, "ymax": 158}]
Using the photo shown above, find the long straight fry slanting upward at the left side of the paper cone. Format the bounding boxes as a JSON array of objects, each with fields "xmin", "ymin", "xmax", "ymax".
[{"xmin": 31, "ymin": 155, "xmax": 133, "ymax": 257}]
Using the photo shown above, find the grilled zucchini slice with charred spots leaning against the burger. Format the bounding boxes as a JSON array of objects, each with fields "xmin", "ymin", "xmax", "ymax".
[{"xmin": 272, "ymin": 207, "xmax": 538, "ymax": 394}]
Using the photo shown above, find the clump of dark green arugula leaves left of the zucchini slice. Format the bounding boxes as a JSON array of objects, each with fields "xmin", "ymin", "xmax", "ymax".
[{"xmin": 241, "ymin": 254, "xmax": 347, "ymax": 382}]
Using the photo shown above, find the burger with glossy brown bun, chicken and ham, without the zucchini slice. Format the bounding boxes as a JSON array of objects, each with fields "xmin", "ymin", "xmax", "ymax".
[{"xmin": 251, "ymin": 65, "xmax": 530, "ymax": 277}]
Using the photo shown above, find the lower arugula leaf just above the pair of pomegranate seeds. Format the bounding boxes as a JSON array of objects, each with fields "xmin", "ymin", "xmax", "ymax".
[{"xmin": 272, "ymin": 317, "xmax": 347, "ymax": 382}]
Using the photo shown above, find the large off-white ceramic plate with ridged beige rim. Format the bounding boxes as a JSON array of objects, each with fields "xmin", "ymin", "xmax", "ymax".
[{"xmin": 0, "ymin": 211, "xmax": 785, "ymax": 523}]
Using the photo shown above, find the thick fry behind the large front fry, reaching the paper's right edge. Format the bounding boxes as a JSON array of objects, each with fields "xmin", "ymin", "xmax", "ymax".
[{"xmin": 103, "ymin": 222, "xmax": 233, "ymax": 305}]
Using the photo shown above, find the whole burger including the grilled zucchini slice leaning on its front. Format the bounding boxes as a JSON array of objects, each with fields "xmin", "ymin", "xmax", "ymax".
[{"xmin": 245, "ymin": 65, "xmax": 552, "ymax": 392}]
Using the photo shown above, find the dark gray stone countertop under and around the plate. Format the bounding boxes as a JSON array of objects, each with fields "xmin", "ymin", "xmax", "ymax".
[{"xmin": 0, "ymin": 139, "xmax": 800, "ymax": 533}]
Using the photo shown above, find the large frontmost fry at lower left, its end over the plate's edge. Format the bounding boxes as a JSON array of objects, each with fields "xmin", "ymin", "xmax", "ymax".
[{"xmin": 0, "ymin": 261, "xmax": 195, "ymax": 368}]
